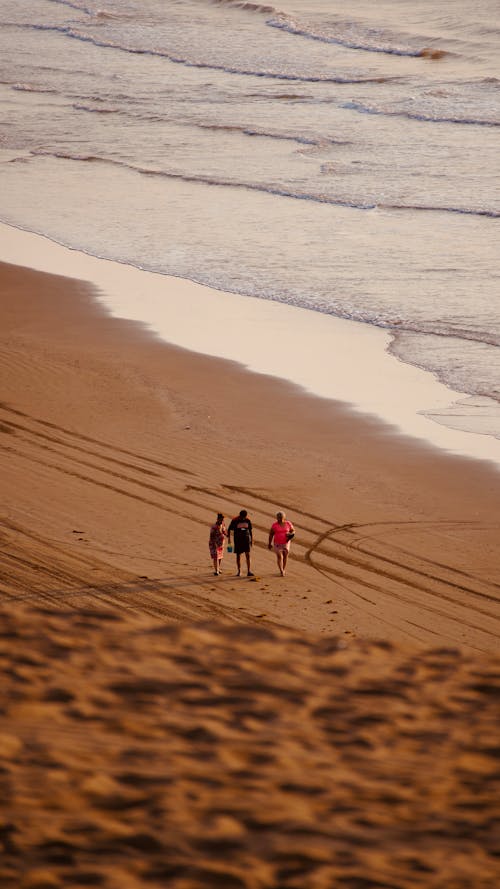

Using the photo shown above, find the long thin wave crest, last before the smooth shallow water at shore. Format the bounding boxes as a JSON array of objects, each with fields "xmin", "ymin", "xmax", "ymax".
[{"xmin": 31, "ymin": 149, "xmax": 500, "ymax": 219}]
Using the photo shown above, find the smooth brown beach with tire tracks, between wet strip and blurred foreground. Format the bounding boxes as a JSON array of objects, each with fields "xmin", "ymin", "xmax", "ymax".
[{"xmin": 0, "ymin": 253, "xmax": 500, "ymax": 652}]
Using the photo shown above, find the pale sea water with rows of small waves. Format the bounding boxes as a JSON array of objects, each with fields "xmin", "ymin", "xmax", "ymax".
[{"xmin": 0, "ymin": 0, "xmax": 500, "ymax": 450}]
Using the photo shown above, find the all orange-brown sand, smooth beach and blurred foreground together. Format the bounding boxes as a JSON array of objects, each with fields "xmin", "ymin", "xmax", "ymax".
[{"xmin": 0, "ymin": 264, "xmax": 500, "ymax": 889}]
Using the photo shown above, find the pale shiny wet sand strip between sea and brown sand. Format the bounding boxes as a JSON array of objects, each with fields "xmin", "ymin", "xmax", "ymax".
[{"xmin": 0, "ymin": 224, "xmax": 500, "ymax": 470}]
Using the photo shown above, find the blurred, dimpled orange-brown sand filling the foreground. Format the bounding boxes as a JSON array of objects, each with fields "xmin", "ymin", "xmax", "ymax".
[{"xmin": 0, "ymin": 605, "xmax": 500, "ymax": 889}]
